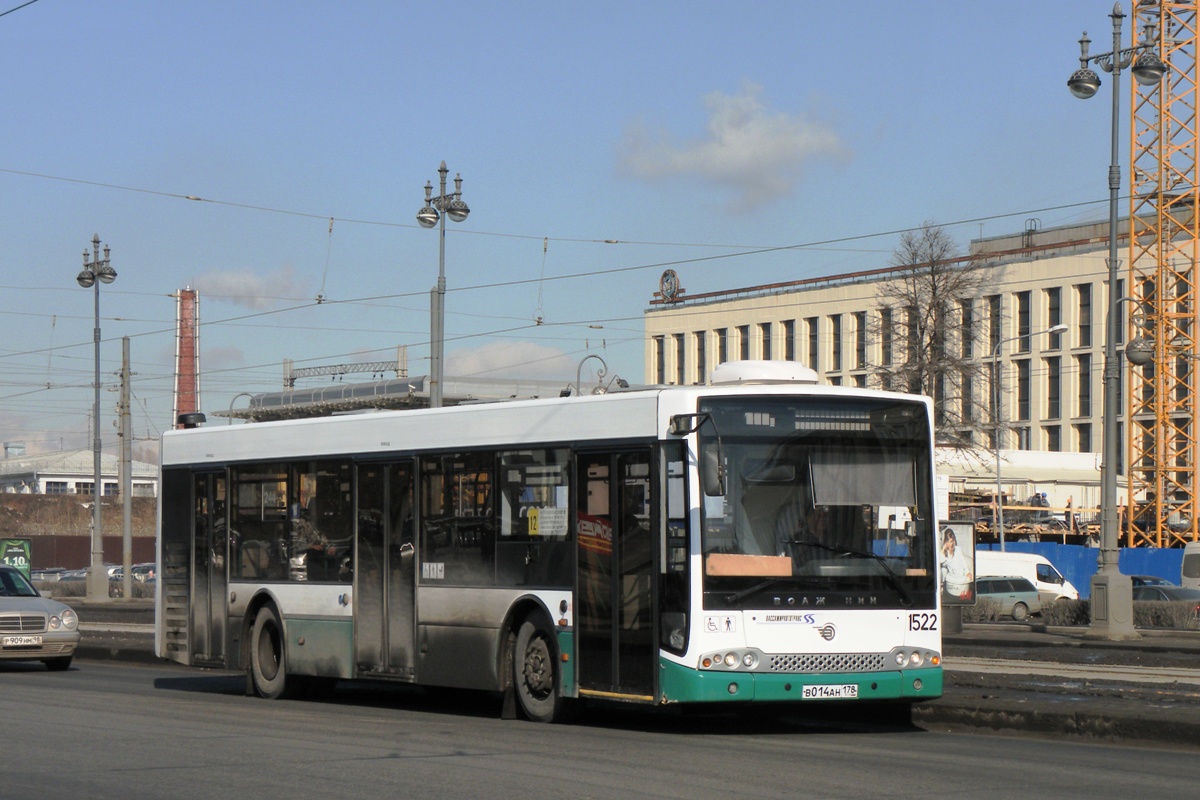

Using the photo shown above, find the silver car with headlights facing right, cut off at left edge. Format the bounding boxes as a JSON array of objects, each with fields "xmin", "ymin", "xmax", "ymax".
[{"xmin": 0, "ymin": 565, "xmax": 79, "ymax": 670}]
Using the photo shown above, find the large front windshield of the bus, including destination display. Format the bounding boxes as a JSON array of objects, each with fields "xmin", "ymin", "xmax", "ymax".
[{"xmin": 698, "ymin": 397, "xmax": 936, "ymax": 608}]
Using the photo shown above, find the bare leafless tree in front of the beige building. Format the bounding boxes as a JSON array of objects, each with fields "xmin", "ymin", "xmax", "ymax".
[{"xmin": 872, "ymin": 221, "xmax": 988, "ymax": 445}]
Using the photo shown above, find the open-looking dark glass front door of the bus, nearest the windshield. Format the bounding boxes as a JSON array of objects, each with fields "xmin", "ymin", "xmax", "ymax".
[{"xmin": 576, "ymin": 451, "xmax": 658, "ymax": 700}]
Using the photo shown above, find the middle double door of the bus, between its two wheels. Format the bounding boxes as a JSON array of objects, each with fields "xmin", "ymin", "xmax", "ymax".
[{"xmin": 354, "ymin": 462, "xmax": 415, "ymax": 680}]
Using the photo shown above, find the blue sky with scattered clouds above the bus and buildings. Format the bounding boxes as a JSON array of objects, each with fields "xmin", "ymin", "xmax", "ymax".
[{"xmin": 0, "ymin": 0, "xmax": 1132, "ymax": 458}]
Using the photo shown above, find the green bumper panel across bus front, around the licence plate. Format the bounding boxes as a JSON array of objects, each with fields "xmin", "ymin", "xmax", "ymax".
[{"xmin": 659, "ymin": 660, "xmax": 942, "ymax": 703}]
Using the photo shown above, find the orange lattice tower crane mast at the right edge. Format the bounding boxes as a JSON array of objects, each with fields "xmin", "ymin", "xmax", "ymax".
[{"xmin": 1128, "ymin": 0, "xmax": 1200, "ymax": 547}]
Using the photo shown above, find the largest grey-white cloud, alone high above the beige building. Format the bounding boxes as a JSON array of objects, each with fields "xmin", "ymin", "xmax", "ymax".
[{"xmin": 619, "ymin": 84, "xmax": 847, "ymax": 211}]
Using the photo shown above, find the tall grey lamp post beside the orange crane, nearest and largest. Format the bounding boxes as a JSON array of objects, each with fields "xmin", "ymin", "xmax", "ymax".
[{"xmin": 1067, "ymin": 4, "xmax": 1166, "ymax": 640}]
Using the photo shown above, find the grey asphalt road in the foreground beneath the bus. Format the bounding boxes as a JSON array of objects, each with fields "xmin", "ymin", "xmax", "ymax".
[{"xmin": 9, "ymin": 660, "xmax": 1200, "ymax": 800}]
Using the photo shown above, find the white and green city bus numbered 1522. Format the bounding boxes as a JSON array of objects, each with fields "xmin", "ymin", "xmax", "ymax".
[{"xmin": 155, "ymin": 362, "xmax": 942, "ymax": 722}]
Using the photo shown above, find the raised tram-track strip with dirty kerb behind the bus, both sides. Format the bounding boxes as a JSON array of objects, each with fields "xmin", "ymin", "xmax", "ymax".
[{"xmin": 68, "ymin": 601, "xmax": 1200, "ymax": 750}]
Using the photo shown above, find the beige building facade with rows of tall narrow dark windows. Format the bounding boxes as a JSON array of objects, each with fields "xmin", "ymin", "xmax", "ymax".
[{"xmin": 644, "ymin": 223, "xmax": 1132, "ymax": 462}]
